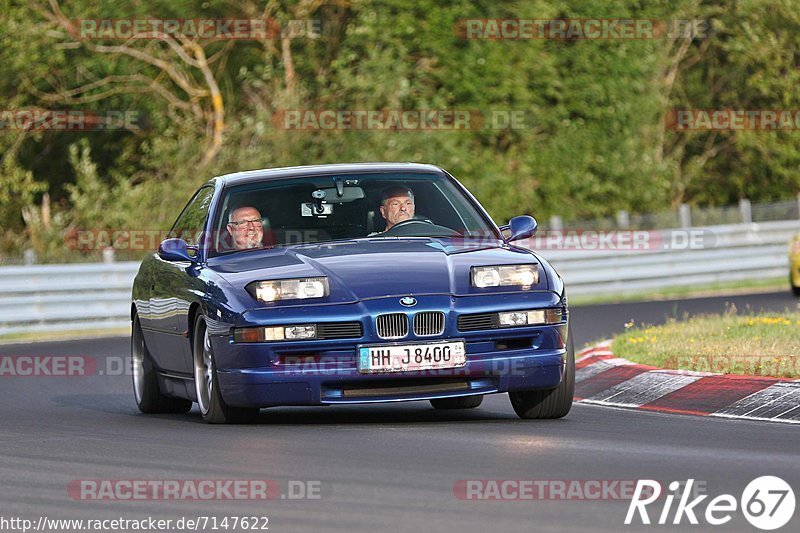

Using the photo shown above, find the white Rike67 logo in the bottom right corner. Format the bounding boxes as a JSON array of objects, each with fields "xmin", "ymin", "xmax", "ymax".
[{"xmin": 625, "ymin": 476, "xmax": 796, "ymax": 531}]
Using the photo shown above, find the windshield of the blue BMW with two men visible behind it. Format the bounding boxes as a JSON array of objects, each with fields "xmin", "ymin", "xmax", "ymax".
[{"xmin": 211, "ymin": 173, "xmax": 497, "ymax": 255}]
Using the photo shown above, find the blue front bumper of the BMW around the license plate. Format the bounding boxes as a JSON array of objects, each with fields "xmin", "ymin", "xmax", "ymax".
[{"xmin": 211, "ymin": 291, "xmax": 567, "ymax": 407}]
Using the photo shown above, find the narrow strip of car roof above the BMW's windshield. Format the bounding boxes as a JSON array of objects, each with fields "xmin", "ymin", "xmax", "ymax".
[{"xmin": 211, "ymin": 163, "xmax": 444, "ymax": 185}]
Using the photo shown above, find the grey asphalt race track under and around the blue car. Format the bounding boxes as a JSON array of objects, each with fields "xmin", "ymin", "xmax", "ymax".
[{"xmin": 0, "ymin": 293, "xmax": 800, "ymax": 532}]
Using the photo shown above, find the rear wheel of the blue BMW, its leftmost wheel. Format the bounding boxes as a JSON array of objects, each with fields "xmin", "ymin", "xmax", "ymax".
[{"xmin": 131, "ymin": 316, "xmax": 192, "ymax": 414}]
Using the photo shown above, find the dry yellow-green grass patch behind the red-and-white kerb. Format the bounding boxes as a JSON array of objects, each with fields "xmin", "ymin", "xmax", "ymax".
[{"xmin": 611, "ymin": 311, "xmax": 800, "ymax": 379}]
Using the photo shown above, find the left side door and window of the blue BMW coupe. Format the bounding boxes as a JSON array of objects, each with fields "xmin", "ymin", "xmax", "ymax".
[{"xmin": 150, "ymin": 186, "xmax": 214, "ymax": 374}]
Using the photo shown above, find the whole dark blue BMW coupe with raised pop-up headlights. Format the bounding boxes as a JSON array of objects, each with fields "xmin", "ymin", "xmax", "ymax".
[{"xmin": 131, "ymin": 163, "xmax": 575, "ymax": 423}]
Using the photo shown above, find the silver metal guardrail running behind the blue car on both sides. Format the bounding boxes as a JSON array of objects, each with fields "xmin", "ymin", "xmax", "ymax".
[{"xmin": 0, "ymin": 220, "xmax": 800, "ymax": 335}]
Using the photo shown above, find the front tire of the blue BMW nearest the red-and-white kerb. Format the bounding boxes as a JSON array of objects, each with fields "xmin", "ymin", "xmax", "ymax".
[{"xmin": 508, "ymin": 331, "xmax": 575, "ymax": 419}]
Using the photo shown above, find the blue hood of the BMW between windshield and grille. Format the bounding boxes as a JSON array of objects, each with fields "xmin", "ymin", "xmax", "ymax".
[{"xmin": 209, "ymin": 237, "xmax": 549, "ymax": 305}]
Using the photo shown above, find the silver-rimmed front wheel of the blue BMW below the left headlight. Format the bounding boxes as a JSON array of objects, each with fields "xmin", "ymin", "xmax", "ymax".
[{"xmin": 192, "ymin": 316, "xmax": 259, "ymax": 424}]
